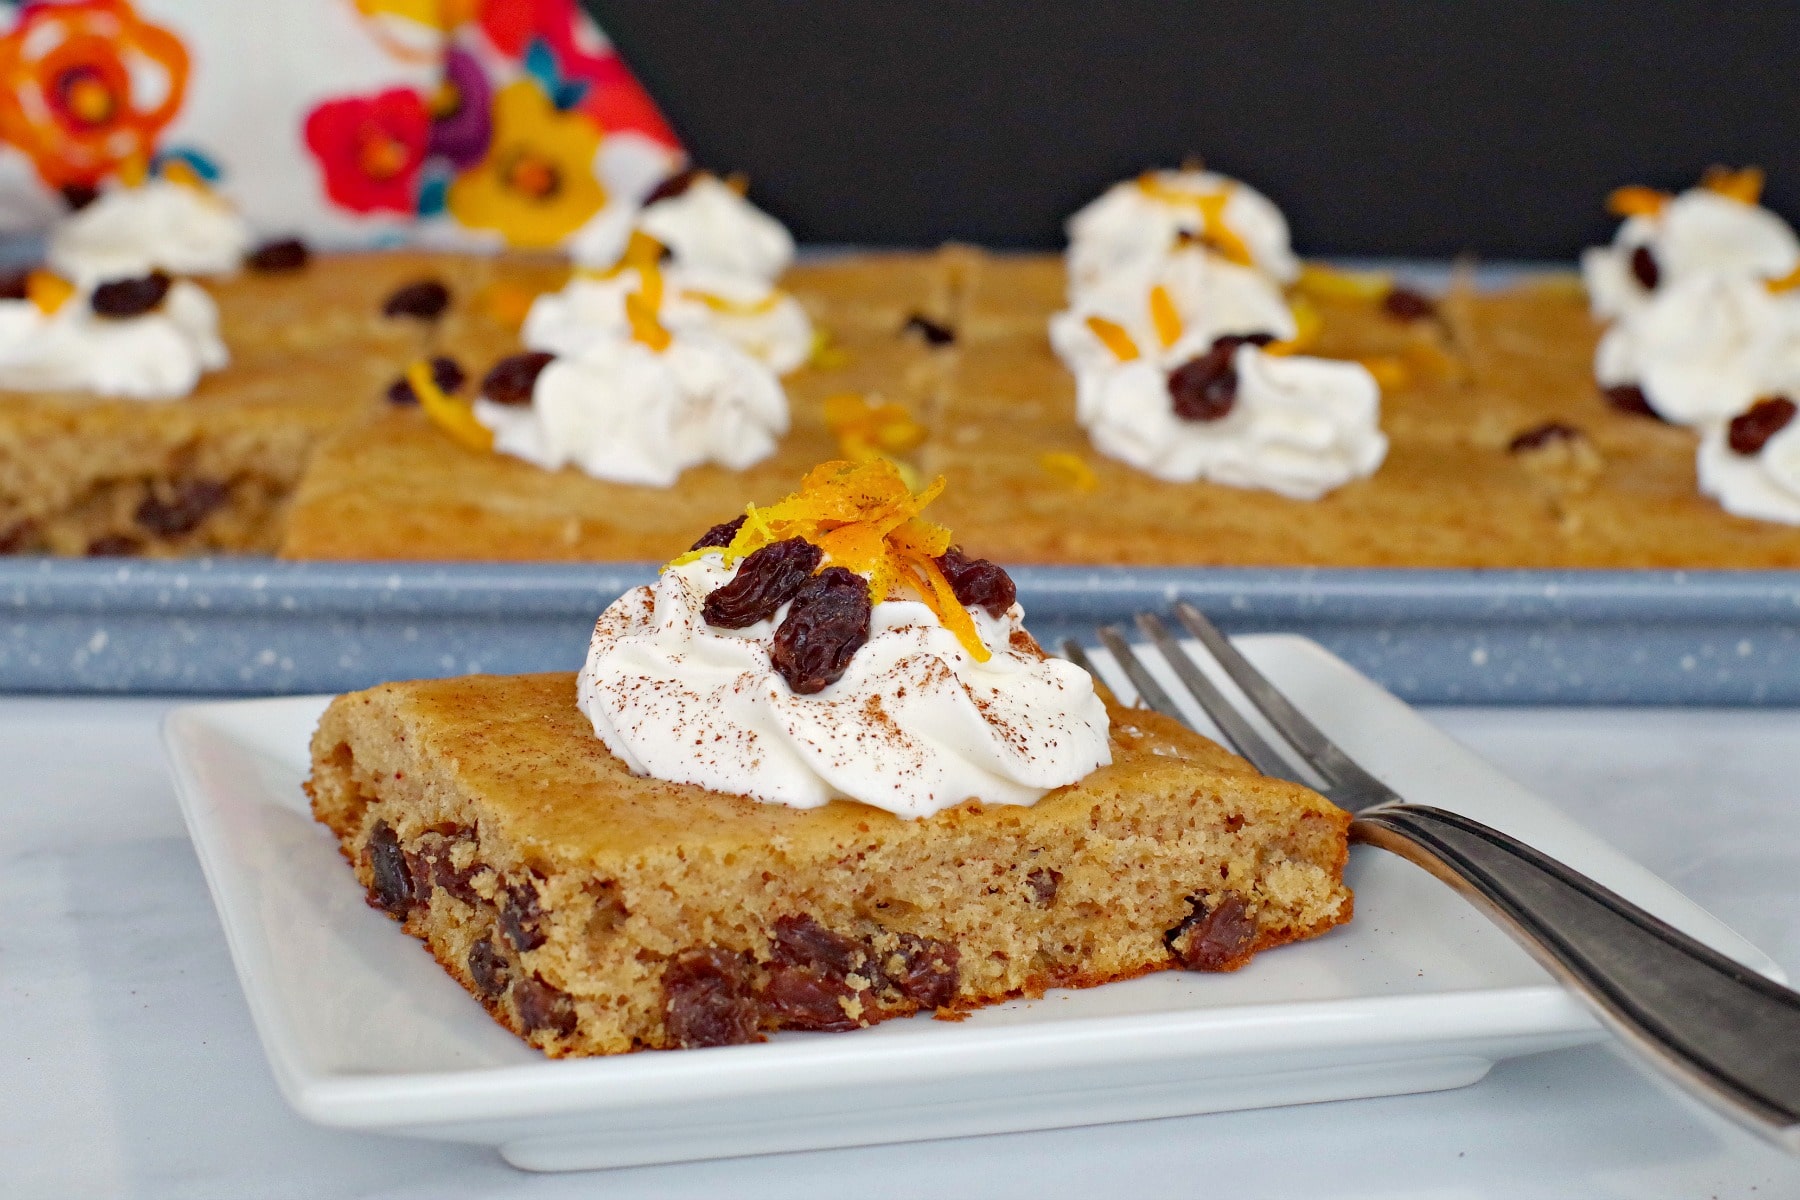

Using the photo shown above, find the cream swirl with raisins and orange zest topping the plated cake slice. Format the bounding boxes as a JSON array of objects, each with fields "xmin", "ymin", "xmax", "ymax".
[{"xmin": 580, "ymin": 461, "xmax": 1111, "ymax": 817}]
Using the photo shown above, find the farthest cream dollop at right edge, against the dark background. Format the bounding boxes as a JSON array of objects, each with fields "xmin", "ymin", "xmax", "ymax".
[{"xmin": 1580, "ymin": 185, "xmax": 1800, "ymax": 320}]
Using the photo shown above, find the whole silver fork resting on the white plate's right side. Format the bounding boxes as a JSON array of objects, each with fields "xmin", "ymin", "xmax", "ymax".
[{"xmin": 1064, "ymin": 603, "xmax": 1800, "ymax": 1153}]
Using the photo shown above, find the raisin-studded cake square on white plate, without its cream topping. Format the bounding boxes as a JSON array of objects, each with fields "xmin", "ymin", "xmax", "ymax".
[{"xmin": 308, "ymin": 675, "xmax": 1352, "ymax": 1056}]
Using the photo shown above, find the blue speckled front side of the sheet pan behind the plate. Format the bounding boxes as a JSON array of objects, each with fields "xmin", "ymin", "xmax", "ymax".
[{"xmin": 0, "ymin": 558, "xmax": 1800, "ymax": 705}]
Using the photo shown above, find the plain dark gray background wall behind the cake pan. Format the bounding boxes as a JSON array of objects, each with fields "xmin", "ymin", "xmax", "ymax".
[{"xmin": 587, "ymin": 0, "xmax": 1800, "ymax": 259}]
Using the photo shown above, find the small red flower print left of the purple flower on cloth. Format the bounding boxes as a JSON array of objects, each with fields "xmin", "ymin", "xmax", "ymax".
[{"xmin": 306, "ymin": 88, "xmax": 432, "ymax": 212}]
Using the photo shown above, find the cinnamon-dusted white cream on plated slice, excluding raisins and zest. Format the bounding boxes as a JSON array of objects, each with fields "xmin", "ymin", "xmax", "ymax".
[{"xmin": 578, "ymin": 552, "xmax": 1112, "ymax": 817}]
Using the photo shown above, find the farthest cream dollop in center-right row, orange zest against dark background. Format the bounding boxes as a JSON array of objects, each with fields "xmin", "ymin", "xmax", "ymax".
[{"xmin": 1066, "ymin": 169, "xmax": 1300, "ymax": 297}]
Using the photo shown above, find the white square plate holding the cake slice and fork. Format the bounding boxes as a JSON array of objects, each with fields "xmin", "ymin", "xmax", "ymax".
[{"xmin": 166, "ymin": 635, "xmax": 1778, "ymax": 1169}]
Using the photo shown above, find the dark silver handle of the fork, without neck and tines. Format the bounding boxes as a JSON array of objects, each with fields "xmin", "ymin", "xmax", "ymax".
[{"xmin": 1350, "ymin": 804, "xmax": 1800, "ymax": 1153}]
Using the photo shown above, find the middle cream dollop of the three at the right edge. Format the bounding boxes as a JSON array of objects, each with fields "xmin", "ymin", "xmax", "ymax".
[{"xmin": 1595, "ymin": 275, "xmax": 1800, "ymax": 426}]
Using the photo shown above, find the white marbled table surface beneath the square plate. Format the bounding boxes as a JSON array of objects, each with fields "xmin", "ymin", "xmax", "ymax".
[{"xmin": 0, "ymin": 698, "xmax": 1800, "ymax": 1200}]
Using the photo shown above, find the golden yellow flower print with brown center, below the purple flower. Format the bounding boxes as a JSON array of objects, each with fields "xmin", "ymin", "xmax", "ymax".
[{"xmin": 448, "ymin": 79, "xmax": 607, "ymax": 250}]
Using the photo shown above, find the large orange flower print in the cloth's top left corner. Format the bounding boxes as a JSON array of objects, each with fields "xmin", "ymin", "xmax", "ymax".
[{"xmin": 0, "ymin": 0, "xmax": 187, "ymax": 189}]
